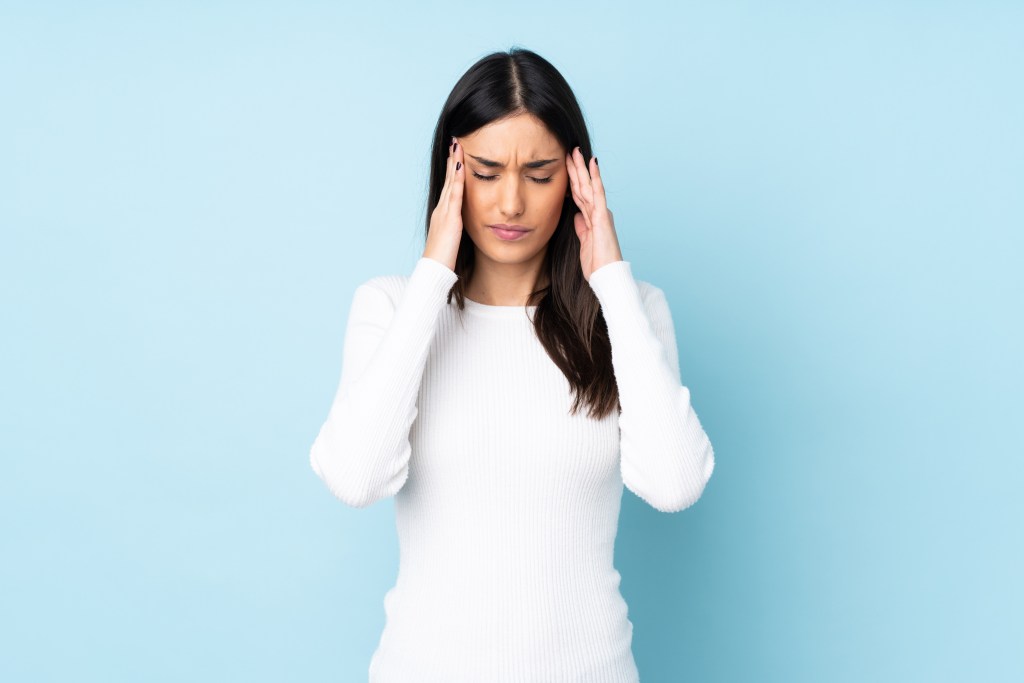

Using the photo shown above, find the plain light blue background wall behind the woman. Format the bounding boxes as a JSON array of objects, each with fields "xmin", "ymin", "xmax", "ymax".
[{"xmin": 0, "ymin": 1, "xmax": 1024, "ymax": 683}]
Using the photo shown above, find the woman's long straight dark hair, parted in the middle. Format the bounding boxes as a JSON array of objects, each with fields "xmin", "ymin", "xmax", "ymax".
[{"xmin": 424, "ymin": 47, "xmax": 622, "ymax": 419}]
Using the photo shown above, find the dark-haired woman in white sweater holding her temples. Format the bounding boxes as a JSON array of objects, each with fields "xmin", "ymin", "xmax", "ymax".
[{"xmin": 310, "ymin": 48, "xmax": 715, "ymax": 683}]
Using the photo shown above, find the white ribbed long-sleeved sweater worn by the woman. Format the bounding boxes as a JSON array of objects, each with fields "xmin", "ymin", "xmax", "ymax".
[{"xmin": 310, "ymin": 257, "xmax": 715, "ymax": 683}]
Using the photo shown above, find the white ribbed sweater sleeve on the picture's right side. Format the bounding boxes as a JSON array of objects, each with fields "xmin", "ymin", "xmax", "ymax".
[{"xmin": 590, "ymin": 261, "xmax": 715, "ymax": 512}]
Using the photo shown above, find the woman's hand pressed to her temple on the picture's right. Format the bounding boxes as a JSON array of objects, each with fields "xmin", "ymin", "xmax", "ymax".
[{"xmin": 565, "ymin": 147, "xmax": 623, "ymax": 282}]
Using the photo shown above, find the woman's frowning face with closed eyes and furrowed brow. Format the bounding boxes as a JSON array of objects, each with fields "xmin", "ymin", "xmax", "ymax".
[{"xmin": 458, "ymin": 114, "xmax": 571, "ymax": 263}]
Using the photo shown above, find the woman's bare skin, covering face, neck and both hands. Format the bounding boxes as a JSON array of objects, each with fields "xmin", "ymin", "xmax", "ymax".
[{"xmin": 424, "ymin": 114, "xmax": 623, "ymax": 306}]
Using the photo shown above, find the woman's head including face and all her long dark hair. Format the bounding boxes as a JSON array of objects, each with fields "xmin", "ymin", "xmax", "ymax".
[{"xmin": 425, "ymin": 48, "xmax": 618, "ymax": 417}]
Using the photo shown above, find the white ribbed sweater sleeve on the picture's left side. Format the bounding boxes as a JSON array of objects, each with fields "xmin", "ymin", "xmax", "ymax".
[{"xmin": 309, "ymin": 256, "xmax": 458, "ymax": 508}]
